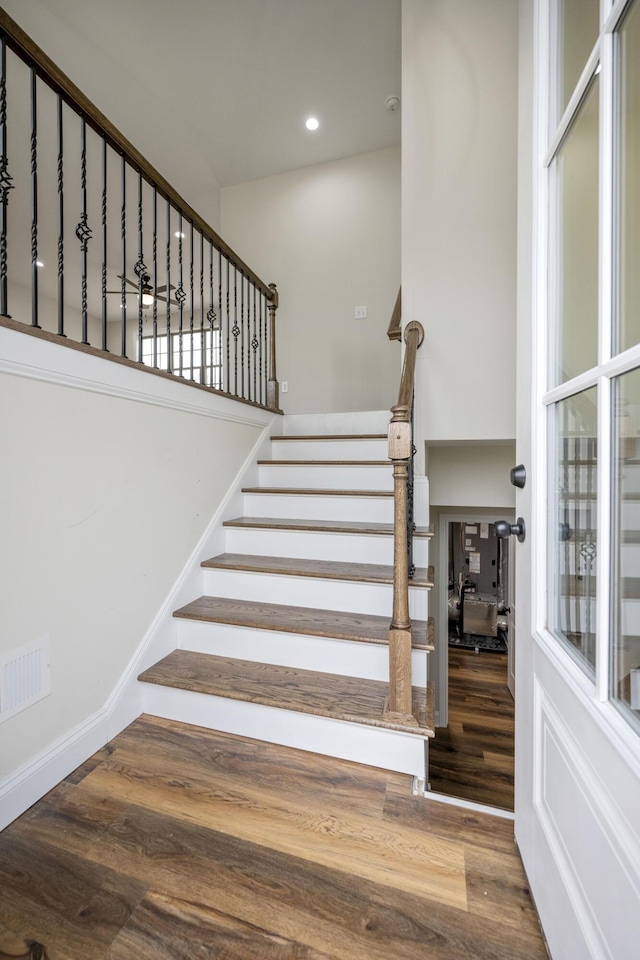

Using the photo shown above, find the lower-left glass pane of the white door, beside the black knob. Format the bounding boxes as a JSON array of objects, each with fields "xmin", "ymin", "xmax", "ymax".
[{"xmin": 548, "ymin": 387, "xmax": 598, "ymax": 674}]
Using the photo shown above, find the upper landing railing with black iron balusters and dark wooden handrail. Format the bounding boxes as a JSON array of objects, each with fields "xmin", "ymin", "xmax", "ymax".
[{"xmin": 0, "ymin": 8, "xmax": 279, "ymax": 409}]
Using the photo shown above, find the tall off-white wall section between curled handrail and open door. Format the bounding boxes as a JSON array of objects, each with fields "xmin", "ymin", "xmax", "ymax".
[{"xmin": 402, "ymin": 0, "xmax": 518, "ymax": 441}]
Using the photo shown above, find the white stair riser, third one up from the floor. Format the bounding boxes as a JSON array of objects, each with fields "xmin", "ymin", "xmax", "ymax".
[{"xmin": 203, "ymin": 569, "xmax": 428, "ymax": 620}]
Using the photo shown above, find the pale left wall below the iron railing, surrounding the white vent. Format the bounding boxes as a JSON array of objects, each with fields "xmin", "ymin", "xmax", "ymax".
[{"xmin": 0, "ymin": 329, "xmax": 272, "ymax": 782}]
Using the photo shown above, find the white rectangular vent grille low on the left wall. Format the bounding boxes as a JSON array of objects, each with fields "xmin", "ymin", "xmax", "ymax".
[{"xmin": 0, "ymin": 638, "xmax": 51, "ymax": 723}]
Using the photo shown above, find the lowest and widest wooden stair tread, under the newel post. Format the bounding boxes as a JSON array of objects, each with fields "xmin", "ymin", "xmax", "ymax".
[{"xmin": 138, "ymin": 650, "xmax": 434, "ymax": 737}]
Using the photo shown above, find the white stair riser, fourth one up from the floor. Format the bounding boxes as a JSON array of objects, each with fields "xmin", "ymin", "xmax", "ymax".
[{"xmin": 225, "ymin": 527, "xmax": 429, "ymax": 567}]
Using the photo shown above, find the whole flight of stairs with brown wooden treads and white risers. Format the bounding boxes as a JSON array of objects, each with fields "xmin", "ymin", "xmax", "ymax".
[{"xmin": 139, "ymin": 416, "xmax": 434, "ymax": 779}]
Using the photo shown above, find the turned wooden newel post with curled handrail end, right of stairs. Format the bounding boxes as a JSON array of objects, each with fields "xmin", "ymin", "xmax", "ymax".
[{"xmin": 385, "ymin": 320, "xmax": 424, "ymax": 724}]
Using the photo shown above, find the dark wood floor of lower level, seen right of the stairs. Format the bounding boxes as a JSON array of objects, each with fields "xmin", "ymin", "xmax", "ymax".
[{"xmin": 429, "ymin": 647, "xmax": 514, "ymax": 810}]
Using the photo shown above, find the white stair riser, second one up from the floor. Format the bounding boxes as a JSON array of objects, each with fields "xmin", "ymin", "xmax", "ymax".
[{"xmin": 177, "ymin": 620, "xmax": 427, "ymax": 687}]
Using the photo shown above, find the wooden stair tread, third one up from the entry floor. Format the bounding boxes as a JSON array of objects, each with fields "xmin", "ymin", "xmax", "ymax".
[{"xmin": 200, "ymin": 553, "xmax": 434, "ymax": 588}]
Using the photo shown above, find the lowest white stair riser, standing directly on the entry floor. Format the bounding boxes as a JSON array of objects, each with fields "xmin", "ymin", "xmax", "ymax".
[{"xmin": 143, "ymin": 684, "xmax": 428, "ymax": 779}]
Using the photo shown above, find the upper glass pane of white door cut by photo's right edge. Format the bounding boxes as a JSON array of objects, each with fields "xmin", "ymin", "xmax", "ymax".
[{"xmin": 618, "ymin": 0, "xmax": 640, "ymax": 350}]
